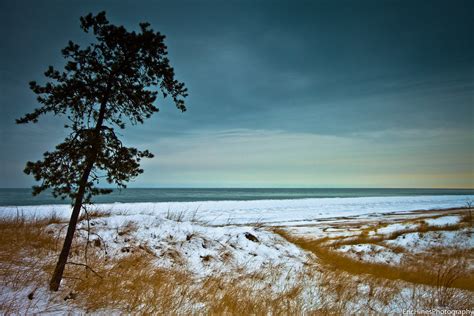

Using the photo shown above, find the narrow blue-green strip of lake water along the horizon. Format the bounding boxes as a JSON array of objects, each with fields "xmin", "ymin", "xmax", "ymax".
[{"xmin": 0, "ymin": 189, "xmax": 474, "ymax": 206}]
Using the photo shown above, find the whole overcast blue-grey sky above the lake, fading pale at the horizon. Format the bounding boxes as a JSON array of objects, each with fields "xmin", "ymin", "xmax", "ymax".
[{"xmin": 0, "ymin": 0, "xmax": 474, "ymax": 188}]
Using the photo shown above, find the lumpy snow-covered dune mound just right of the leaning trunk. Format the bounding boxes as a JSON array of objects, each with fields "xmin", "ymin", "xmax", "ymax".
[{"xmin": 63, "ymin": 214, "xmax": 308, "ymax": 277}]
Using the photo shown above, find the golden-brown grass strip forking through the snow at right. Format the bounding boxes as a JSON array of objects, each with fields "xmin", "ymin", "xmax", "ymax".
[{"xmin": 274, "ymin": 211, "xmax": 474, "ymax": 291}]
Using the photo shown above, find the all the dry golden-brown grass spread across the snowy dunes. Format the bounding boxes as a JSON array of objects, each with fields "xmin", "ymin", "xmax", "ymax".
[{"xmin": 0, "ymin": 210, "xmax": 474, "ymax": 315}]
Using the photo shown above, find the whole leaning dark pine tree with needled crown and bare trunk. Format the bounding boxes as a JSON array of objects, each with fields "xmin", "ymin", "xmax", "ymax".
[{"xmin": 17, "ymin": 12, "xmax": 187, "ymax": 291}]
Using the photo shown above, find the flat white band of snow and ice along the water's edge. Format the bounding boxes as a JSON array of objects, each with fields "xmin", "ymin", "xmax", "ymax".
[{"xmin": 0, "ymin": 195, "xmax": 474, "ymax": 225}]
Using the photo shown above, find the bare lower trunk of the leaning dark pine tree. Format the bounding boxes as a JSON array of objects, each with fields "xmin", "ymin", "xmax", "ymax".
[{"xmin": 49, "ymin": 160, "xmax": 94, "ymax": 291}]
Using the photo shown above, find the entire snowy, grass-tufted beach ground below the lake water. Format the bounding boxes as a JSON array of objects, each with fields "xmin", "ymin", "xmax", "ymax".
[{"xmin": 0, "ymin": 195, "xmax": 474, "ymax": 314}]
